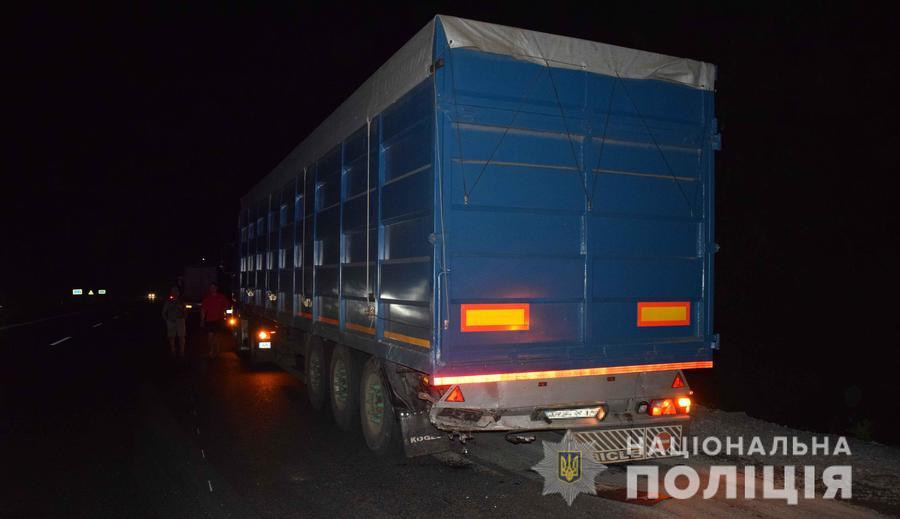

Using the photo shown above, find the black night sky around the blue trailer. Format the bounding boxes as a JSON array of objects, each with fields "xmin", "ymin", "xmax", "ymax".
[{"xmin": 7, "ymin": 2, "xmax": 900, "ymax": 438}]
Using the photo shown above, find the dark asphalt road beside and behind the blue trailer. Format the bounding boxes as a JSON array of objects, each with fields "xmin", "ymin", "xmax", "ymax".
[{"xmin": 0, "ymin": 305, "xmax": 884, "ymax": 518}]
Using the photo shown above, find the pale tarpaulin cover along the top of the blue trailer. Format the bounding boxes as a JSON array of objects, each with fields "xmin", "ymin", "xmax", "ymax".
[{"xmin": 244, "ymin": 15, "xmax": 716, "ymax": 203}]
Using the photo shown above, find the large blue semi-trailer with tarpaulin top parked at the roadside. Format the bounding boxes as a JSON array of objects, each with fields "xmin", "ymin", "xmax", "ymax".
[{"xmin": 237, "ymin": 16, "xmax": 719, "ymax": 463}]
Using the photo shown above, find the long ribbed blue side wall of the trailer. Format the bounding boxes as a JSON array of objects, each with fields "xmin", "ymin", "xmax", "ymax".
[{"xmin": 239, "ymin": 79, "xmax": 435, "ymax": 372}]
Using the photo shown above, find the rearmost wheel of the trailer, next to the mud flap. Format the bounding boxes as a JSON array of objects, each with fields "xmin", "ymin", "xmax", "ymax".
[{"xmin": 359, "ymin": 357, "xmax": 400, "ymax": 456}]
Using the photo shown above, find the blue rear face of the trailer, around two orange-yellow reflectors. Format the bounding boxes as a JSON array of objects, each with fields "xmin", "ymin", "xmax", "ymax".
[{"xmin": 434, "ymin": 23, "xmax": 715, "ymax": 375}]
